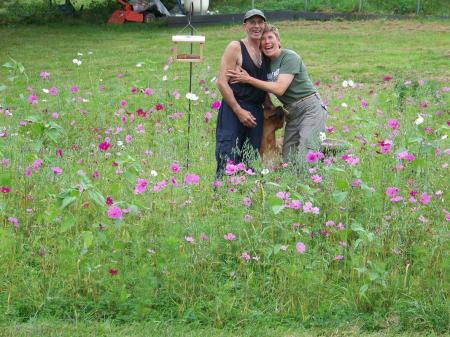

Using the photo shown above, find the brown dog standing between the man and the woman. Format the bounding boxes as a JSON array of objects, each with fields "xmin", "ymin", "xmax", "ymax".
[{"xmin": 259, "ymin": 106, "xmax": 284, "ymax": 166}]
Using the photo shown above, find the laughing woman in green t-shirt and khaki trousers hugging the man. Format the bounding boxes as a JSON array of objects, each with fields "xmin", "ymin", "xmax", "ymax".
[{"xmin": 227, "ymin": 25, "xmax": 327, "ymax": 162}]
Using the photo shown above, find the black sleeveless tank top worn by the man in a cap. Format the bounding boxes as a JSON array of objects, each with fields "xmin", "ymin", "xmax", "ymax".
[{"xmin": 230, "ymin": 41, "xmax": 270, "ymax": 104}]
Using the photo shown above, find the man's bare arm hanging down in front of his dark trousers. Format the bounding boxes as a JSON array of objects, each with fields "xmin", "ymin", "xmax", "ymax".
[{"xmin": 217, "ymin": 41, "xmax": 256, "ymax": 127}]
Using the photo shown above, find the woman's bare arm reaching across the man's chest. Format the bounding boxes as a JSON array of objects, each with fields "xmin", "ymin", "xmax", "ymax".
[{"xmin": 226, "ymin": 69, "xmax": 294, "ymax": 96}]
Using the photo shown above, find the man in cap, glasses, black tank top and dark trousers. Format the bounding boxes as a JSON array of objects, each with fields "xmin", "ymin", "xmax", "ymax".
[{"xmin": 216, "ymin": 9, "xmax": 271, "ymax": 178}]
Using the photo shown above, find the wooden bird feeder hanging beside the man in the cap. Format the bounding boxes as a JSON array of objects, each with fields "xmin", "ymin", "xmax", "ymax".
[{"xmin": 172, "ymin": 35, "xmax": 205, "ymax": 62}]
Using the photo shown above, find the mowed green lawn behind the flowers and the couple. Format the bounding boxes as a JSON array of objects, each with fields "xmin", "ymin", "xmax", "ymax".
[{"xmin": 0, "ymin": 20, "xmax": 450, "ymax": 82}]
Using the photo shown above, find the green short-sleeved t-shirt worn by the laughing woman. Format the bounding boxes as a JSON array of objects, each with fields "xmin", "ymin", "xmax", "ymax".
[{"xmin": 267, "ymin": 49, "xmax": 316, "ymax": 105}]
